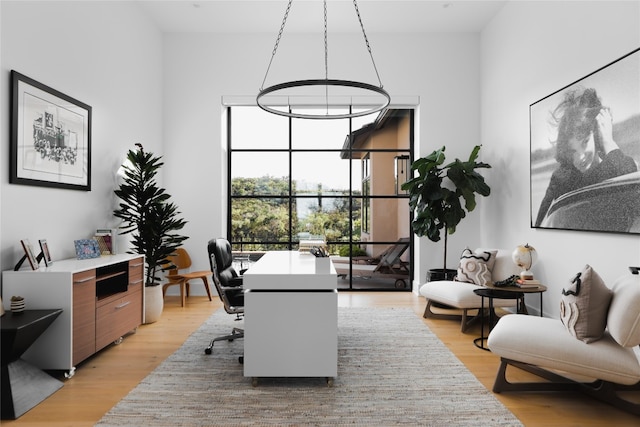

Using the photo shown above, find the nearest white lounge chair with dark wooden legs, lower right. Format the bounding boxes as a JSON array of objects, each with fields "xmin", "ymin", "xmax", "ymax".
[{"xmin": 488, "ymin": 274, "xmax": 640, "ymax": 415}]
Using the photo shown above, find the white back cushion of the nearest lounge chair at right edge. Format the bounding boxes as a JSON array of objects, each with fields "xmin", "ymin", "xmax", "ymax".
[{"xmin": 607, "ymin": 274, "xmax": 640, "ymax": 347}]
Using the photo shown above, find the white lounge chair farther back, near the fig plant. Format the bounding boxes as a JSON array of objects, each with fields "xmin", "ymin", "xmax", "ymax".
[{"xmin": 420, "ymin": 248, "xmax": 520, "ymax": 332}]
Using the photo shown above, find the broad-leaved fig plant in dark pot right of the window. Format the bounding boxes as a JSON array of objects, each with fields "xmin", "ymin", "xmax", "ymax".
[{"xmin": 402, "ymin": 145, "xmax": 491, "ymax": 281}]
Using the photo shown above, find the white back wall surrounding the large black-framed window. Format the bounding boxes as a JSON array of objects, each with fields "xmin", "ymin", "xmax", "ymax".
[{"xmin": 164, "ymin": 34, "xmax": 480, "ymax": 283}]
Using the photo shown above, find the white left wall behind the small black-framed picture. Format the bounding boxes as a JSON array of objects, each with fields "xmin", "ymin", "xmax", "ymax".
[{"xmin": 0, "ymin": 1, "xmax": 163, "ymax": 270}]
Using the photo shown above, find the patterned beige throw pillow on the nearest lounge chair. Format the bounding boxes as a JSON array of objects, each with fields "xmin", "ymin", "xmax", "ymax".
[{"xmin": 560, "ymin": 265, "xmax": 613, "ymax": 343}]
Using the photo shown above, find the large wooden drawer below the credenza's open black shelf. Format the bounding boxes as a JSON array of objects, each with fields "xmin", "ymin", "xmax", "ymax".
[{"xmin": 96, "ymin": 290, "xmax": 142, "ymax": 351}]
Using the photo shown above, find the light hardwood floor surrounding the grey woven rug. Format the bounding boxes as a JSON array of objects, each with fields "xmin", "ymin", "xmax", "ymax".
[{"xmin": 2, "ymin": 292, "xmax": 640, "ymax": 427}]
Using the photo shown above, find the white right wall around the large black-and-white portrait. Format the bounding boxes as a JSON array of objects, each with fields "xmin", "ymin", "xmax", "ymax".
[{"xmin": 481, "ymin": 1, "xmax": 640, "ymax": 317}]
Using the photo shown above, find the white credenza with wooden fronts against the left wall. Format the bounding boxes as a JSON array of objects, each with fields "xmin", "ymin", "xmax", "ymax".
[{"xmin": 2, "ymin": 254, "xmax": 144, "ymax": 375}]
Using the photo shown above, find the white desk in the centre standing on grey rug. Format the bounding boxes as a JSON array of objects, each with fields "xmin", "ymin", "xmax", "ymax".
[{"xmin": 243, "ymin": 251, "xmax": 338, "ymax": 385}]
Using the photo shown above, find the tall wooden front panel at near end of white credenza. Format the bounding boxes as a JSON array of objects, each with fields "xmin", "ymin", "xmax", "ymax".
[{"xmin": 72, "ymin": 270, "xmax": 96, "ymax": 365}]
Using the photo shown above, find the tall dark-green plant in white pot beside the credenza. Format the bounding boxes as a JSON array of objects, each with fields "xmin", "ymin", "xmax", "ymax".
[{"xmin": 113, "ymin": 144, "xmax": 188, "ymax": 323}]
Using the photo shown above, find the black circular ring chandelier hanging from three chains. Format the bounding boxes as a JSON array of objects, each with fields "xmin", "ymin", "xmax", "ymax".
[{"xmin": 256, "ymin": 0, "xmax": 391, "ymax": 119}]
